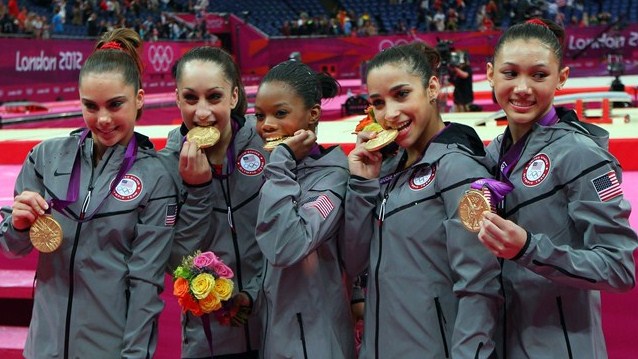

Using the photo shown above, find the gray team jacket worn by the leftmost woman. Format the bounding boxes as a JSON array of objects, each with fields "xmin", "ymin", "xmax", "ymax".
[{"xmin": 0, "ymin": 131, "xmax": 177, "ymax": 358}]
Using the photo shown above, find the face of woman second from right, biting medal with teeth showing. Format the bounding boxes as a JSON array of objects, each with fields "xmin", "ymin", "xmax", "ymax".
[{"xmin": 367, "ymin": 63, "xmax": 443, "ymax": 158}]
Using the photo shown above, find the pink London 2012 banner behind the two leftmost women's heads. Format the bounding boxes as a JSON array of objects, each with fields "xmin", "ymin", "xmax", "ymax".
[{"xmin": 0, "ymin": 39, "xmax": 202, "ymax": 102}]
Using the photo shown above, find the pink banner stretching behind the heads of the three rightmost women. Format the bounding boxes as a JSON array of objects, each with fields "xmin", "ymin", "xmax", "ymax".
[{"xmin": 235, "ymin": 24, "xmax": 638, "ymax": 82}]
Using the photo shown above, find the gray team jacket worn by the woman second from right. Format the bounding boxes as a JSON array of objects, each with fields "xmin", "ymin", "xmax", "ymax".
[{"xmin": 344, "ymin": 124, "xmax": 502, "ymax": 359}]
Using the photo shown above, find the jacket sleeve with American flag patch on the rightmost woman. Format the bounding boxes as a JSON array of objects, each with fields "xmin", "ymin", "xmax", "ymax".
[{"xmin": 516, "ymin": 146, "xmax": 638, "ymax": 292}]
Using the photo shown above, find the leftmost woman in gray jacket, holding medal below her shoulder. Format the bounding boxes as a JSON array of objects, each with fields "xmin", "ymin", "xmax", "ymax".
[{"xmin": 0, "ymin": 29, "xmax": 177, "ymax": 358}]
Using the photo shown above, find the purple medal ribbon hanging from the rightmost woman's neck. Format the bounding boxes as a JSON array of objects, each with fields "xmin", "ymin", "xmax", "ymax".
[{"xmin": 470, "ymin": 106, "xmax": 558, "ymax": 207}]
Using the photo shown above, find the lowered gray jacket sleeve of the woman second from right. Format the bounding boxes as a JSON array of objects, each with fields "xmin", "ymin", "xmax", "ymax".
[{"xmin": 435, "ymin": 154, "xmax": 503, "ymax": 358}]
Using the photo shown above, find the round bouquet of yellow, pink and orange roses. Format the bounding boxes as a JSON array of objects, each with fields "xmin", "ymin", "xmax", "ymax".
[{"xmin": 173, "ymin": 251, "xmax": 234, "ymax": 321}]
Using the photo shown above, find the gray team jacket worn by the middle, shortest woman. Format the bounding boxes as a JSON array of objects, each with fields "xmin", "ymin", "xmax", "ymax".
[{"xmin": 256, "ymin": 145, "xmax": 355, "ymax": 359}]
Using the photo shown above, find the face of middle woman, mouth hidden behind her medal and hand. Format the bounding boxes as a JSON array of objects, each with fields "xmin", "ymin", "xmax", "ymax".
[{"xmin": 255, "ymin": 81, "xmax": 321, "ymax": 140}]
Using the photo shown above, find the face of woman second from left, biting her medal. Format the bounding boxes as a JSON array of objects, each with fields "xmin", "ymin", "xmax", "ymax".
[{"xmin": 176, "ymin": 60, "xmax": 238, "ymax": 142}]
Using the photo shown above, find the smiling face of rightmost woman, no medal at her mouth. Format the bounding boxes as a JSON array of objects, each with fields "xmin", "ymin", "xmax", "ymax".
[{"xmin": 487, "ymin": 39, "xmax": 569, "ymax": 137}]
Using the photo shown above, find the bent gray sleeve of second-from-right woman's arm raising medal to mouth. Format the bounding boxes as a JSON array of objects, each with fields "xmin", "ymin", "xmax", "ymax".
[{"xmin": 341, "ymin": 176, "xmax": 380, "ymax": 278}]
